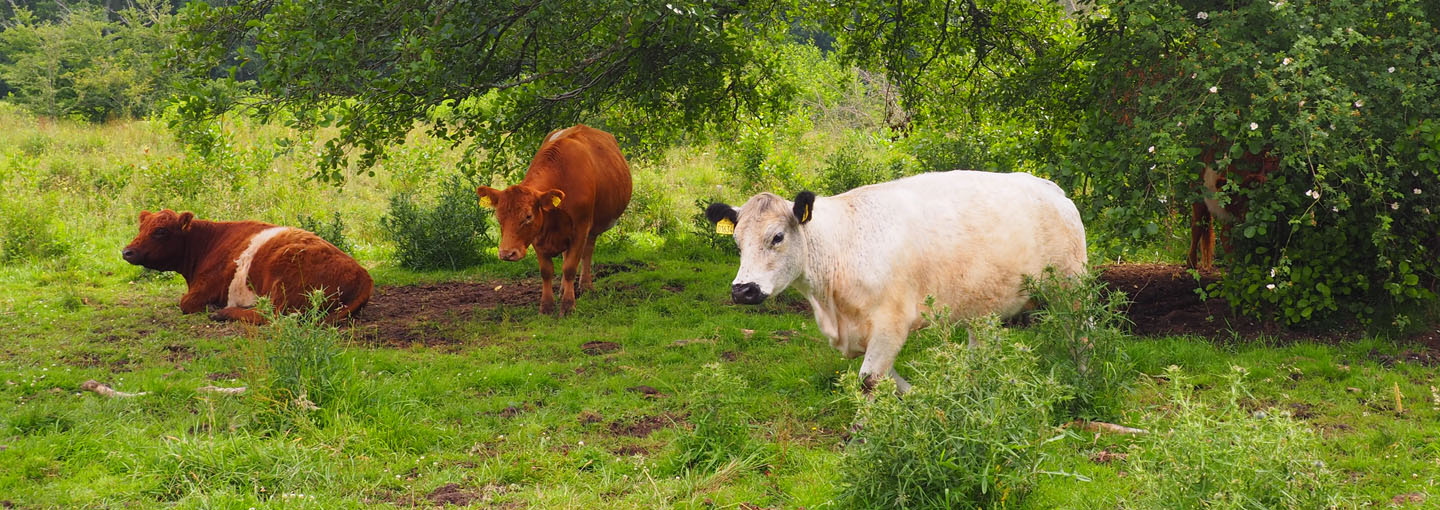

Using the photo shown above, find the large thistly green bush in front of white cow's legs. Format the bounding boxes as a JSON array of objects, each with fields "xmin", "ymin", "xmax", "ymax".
[{"xmin": 840, "ymin": 316, "xmax": 1066, "ymax": 509}]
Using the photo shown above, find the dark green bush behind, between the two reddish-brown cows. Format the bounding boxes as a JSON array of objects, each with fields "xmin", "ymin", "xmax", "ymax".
[{"xmin": 380, "ymin": 176, "xmax": 490, "ymax": 269}]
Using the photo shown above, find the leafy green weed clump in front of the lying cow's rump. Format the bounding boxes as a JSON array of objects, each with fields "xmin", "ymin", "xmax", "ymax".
[{"xmin": 259, "ymin": 290, "xmax": 353, "ymax": 408}]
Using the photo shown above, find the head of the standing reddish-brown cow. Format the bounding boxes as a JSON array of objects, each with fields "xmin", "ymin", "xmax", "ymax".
[{"xmin": 475, "ymin": 184, "xmax": 564, "ymax": 262}]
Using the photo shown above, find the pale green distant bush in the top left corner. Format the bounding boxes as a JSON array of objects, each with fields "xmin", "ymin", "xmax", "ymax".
[{"xmin": 0, "ymin": 0, "xmax": 174, "ymax": 121}]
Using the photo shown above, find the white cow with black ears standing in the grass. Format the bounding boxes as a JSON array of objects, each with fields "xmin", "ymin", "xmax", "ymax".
[{"xmin": 706, "ymin": 170, "xmax": 1086, "ymax": 392}]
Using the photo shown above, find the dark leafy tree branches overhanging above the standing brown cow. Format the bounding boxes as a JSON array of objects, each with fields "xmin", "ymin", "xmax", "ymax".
[{"xmin": 177, "ymin": 0, "xmax": 792, "ymax": 182}]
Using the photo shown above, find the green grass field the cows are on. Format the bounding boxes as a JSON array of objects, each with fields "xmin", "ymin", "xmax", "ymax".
[{"xmin": 0, "ymin": 105, "xmax": 1440, "ymax": 509}]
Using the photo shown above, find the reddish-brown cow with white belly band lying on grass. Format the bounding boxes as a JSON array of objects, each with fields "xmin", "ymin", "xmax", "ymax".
[{"xmin": 121, "ymin": 209, "xmax": 372, "ymax": 324}]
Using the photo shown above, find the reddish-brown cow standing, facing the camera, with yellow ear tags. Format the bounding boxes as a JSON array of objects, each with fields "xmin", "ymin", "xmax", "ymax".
[{"xmin": 475, "ymin": 124, "xmax": 631, "ymax": 316}]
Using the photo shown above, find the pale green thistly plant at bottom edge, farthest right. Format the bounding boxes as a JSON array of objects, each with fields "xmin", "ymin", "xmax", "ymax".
[{"xmin": 1126, "ymin": 366, "xmax": 1356, "ymax": 510}]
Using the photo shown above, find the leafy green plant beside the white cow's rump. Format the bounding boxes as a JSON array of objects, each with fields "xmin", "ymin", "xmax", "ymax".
[{"xmin": 1025, "ymin": 268, "xmax": 1135, "ymax": 419}]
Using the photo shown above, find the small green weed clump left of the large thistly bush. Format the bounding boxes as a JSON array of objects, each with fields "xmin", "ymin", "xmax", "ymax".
[{"xmin": 667, "ymin": 363, "xmax": 766, "ymax": 473}]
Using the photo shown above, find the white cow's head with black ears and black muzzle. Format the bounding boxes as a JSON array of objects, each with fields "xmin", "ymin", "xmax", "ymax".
[{"xmin": 706, "ymin": 192, "xmax": 815, "ymax": 304}]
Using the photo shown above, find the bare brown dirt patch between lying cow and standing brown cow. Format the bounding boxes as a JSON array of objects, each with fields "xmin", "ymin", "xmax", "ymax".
[{"xmin": 353, "ymin": 279, "xmax": 540, "ymax": 346}]
